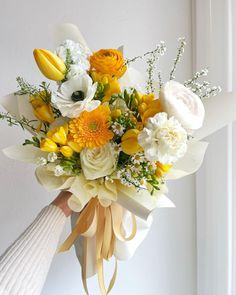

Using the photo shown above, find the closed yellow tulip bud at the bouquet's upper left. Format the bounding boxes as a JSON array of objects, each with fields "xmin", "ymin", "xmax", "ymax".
[{"xmin": 34, "ymin": 49, "xmax": 66, "ymax": 81}]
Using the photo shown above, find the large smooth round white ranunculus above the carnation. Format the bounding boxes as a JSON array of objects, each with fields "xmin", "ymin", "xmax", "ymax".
[{"xmin": 160, "ymin": 81, "xmax": 205, "ymax": 130}]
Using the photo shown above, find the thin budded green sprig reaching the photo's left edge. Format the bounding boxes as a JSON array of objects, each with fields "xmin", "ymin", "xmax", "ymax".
[{"xmin": 0, "ymin": 113, "xmax": 47, "ymax": 134}]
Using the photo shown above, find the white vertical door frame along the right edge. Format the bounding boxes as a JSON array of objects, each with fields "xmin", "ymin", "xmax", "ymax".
[{"xmin": 193, "ymin": 0, "xmax": 236, "ymax": 295}]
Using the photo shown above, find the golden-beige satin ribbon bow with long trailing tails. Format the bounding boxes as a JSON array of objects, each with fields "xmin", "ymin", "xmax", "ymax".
[{"xmin": 59, "ymin": 198, "xmax": 137, "ymax": 295}]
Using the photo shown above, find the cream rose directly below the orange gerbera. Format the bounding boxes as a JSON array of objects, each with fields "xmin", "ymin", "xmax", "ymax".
[{"xmin": 80, "ymin": 143, "xmax": 117, "ymax": 180}]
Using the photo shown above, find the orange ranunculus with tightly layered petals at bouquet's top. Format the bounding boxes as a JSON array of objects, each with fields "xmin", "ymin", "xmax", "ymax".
[{"xmin": 90, "ymin": 49, "xmax": 126, "ymax": 78}]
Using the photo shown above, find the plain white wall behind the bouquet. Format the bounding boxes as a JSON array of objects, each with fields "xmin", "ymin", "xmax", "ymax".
[{"xmin": 0, "ymin": 0, "xmax": 196, "ymax": 295}]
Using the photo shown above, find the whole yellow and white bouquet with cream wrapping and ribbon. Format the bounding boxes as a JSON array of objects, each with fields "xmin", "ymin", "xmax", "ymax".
[{"xmin": 0, "ymin": 25, "xmax": 220, "ymax": 294}]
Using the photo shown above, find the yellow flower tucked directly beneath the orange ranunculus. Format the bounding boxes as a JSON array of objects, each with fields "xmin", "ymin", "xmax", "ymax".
[{"xmin": 91, "ymin": 71, "xmax": 121, "ymax": 102}]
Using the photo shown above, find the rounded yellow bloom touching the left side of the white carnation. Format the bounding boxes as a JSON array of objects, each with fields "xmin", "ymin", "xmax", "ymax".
[{"xmin": 121, "ymin": 129, "xmax": 142, "ymax": 155}]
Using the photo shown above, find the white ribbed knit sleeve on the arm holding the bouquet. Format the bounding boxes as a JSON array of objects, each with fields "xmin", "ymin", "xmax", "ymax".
[{"xmin": 0, "ymin": 205, "xmax": 66, "ymax": 295}]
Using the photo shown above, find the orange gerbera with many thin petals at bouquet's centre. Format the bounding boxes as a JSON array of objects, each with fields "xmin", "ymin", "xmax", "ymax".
[{"xmin": 69, "ymin": 105, "xmax": 113, "ymax": 148}]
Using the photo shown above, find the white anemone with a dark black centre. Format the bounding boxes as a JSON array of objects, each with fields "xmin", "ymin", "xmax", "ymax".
[{"xmin": 52, "ymin": 74, "xmax": 101, "ymax": 118}]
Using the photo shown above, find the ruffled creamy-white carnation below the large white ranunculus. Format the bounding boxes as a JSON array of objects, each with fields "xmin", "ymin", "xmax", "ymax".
[{"xmin": 138, "ymin": 112, "xmax": 187, "ymax": 164}]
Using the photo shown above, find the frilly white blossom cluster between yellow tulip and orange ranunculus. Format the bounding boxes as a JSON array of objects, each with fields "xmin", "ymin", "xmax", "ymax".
[{"xmin": 56, "ymin": 40, "xmax": 91, "ymax": 78}]
